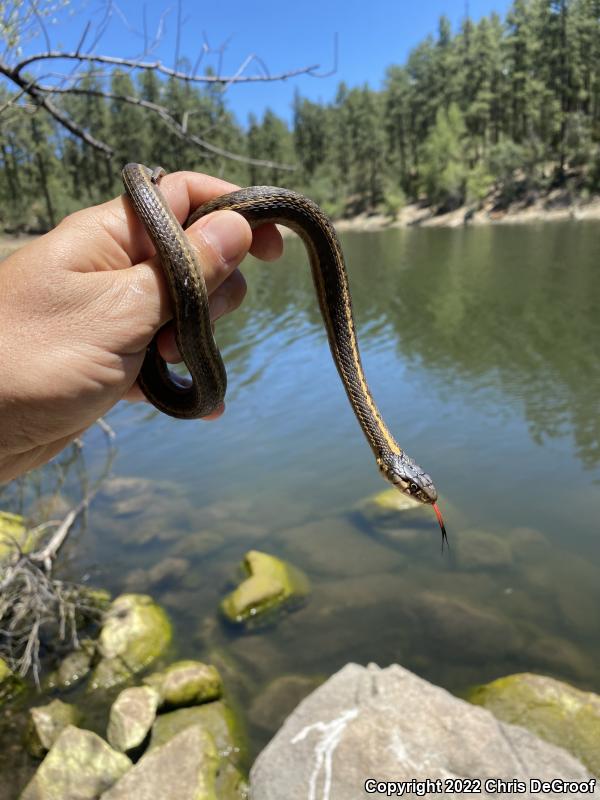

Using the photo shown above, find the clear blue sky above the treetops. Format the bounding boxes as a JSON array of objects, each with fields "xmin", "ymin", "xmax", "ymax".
[{"xmin": 34, "ymin": 0, "xmax": 510, "ymax": 123}]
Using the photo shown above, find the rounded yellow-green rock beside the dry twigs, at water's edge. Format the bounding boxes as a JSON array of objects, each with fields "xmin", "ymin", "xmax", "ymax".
[{"xmin": 90, "ymin": 594, "xmax": 171, "ymax": 689}]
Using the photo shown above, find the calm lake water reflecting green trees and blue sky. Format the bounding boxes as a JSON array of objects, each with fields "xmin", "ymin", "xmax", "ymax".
[{"xmin": 1, "ymin": 222, "xmax": 600, "ymax": 768}]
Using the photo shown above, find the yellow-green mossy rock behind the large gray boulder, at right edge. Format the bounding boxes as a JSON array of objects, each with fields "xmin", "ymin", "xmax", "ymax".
[{"xmin": 468, "ymin": 672, "xmax": 600, "ymax": 777}]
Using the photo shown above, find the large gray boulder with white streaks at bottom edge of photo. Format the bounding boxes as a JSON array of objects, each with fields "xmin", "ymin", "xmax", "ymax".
[{"xmin": 250, "ymin": 664, "xmax": 600, "ymax": 800}]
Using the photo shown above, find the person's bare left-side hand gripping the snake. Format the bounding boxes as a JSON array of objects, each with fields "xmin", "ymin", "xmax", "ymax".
[{"xmin": 0, "ymin": 172, "xmax": 282, "ymax": 481}]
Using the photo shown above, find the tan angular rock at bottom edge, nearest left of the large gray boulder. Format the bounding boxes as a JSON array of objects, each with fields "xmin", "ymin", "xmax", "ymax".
[{"xmin": 101, "ymin": 725, "xmax": 218, "ymax": 800}]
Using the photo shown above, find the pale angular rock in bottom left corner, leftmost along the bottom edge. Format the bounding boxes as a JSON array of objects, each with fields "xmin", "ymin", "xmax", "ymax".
[{"xmin": 20, "ymin": 725, "xmax": 131, "ymax": 800}]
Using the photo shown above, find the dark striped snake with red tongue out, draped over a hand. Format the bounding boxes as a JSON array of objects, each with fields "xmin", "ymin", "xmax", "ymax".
[{"xmin": 122, "ymin": 164, "xmax": 448, "ymax": 549}]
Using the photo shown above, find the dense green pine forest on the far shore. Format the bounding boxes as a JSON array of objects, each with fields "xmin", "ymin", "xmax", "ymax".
[{"xmin": 0, "ymin": 0, "xmax": 600, "ymax": 229}]
